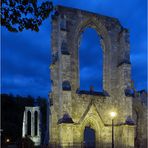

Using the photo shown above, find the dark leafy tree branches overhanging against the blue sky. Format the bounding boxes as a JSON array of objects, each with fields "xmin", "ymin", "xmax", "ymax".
[{"xmin": 1, "ymin": 0, "xmax": 53, "ymax": 32}]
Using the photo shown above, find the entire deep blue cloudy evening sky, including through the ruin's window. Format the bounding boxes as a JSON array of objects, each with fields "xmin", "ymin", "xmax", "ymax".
[{"xmin": 1, "ymin": 0, "xmax": 147, "ymax": 98}]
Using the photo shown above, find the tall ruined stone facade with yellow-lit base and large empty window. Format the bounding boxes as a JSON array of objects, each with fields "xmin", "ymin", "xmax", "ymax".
[{"xmin": 50, "ymin": 6, "xmax": 146, "ymax": 148}]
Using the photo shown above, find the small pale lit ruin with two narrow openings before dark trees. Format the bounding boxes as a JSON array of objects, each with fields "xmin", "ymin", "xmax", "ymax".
[{"xmin": 22, "ymin": 106, "xmax": 41, "ymax": 146}]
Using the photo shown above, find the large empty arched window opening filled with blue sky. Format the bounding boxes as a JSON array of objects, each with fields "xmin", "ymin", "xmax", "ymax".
[{"xmin": 79, "ymin": 28, "xmax": 103, "ymax": 91}]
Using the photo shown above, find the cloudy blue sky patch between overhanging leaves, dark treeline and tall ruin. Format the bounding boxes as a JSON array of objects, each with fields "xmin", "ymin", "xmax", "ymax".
[{"xmin": 2, "ymin": 18, "xmax": 50, "ymax": 98}]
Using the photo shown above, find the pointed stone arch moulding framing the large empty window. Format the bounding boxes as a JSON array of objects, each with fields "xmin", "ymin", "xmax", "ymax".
[{"xmin": 72, "ymin": 18, "xmax": 111, "ymax": 91}]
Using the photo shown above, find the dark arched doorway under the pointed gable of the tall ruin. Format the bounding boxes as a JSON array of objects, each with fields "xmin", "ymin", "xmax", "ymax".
[{"xmin": 84, "ymin": 126, "xmax": 96, "ymax": 148}]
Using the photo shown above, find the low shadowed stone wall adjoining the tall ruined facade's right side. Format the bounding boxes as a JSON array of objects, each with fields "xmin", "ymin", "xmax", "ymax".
[{"xmin": 133, "ymin": 91, "xmax": 148, "ymax": 148}]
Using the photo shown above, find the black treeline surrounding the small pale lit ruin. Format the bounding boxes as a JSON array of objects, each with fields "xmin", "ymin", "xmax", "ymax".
[{"xmin": 1, "ymin": 94, "xmax": 47, "ymax": 145}]
